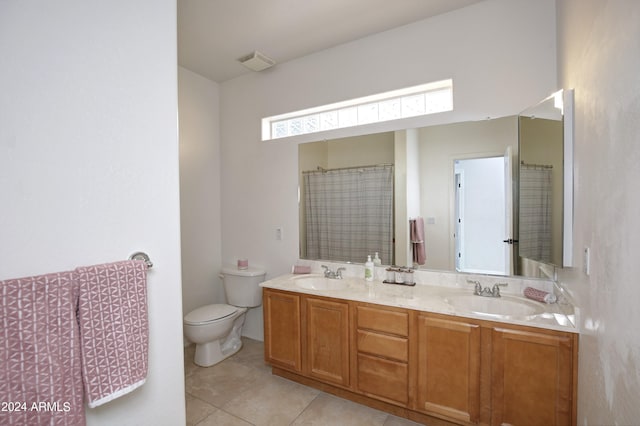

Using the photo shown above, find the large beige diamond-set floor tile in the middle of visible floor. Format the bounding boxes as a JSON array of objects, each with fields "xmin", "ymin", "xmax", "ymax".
[{"xmin": 223, "ymin": 375, "xmax": 320, "ymax": 426}]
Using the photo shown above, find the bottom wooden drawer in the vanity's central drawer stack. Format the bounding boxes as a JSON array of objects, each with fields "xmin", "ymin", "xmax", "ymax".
[{"xmin": 358, "ymin": 354, "xmax": 409, "ymax": 405}]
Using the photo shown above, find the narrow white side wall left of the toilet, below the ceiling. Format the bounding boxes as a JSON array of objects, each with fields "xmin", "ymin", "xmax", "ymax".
[{"xmin": 178, "ymin": 68, "xmax": 226, "ymax": 313}]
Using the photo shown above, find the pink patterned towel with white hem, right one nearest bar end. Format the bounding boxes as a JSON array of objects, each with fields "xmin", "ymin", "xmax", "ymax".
[{"xmin": 76, "ymin": 260, "xmax": 149, "ymax": 408}]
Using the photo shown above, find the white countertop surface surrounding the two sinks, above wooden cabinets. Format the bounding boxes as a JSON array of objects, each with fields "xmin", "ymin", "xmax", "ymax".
[{"xmin": 260, "ymin": 274, "xmax": 578, "ymax": 333}]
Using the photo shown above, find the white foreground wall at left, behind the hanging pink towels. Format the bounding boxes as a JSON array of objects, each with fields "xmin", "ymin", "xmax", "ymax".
[{"xmin": 0, "ymin": 0, "xmax": 185, "ymax": 425}]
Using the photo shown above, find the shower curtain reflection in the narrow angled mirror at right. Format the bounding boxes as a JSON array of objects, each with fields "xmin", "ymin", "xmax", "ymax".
[{"xmin": 519, "ymin": 164, "xmax": 552, "ymax": 263}]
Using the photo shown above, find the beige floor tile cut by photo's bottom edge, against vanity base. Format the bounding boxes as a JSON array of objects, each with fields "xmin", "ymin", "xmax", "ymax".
[{"xmin": 292, "ymin": 393, "xmax": 388, "ymax": 426}]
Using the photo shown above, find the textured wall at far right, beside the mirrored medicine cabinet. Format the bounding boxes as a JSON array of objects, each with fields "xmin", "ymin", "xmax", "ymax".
[{"xmin": 558, "ymin": 0, "xmax": 640, "ymax": 425}]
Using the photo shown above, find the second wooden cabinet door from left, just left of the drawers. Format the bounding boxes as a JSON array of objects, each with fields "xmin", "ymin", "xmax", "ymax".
[{"xmin": 304, "ymin": 297, "xmax": 349, "ymax": 386}]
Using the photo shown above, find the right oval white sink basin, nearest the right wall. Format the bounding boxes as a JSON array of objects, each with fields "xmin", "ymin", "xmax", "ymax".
[{"xmin": 445, "ymin": 294, "xmax": 544, "ymax": 318}]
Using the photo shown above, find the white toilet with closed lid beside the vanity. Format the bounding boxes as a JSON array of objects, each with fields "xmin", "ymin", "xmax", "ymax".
[{"xmin": 184, "ymin": 266, "xmax": 266, "ymax": 367}]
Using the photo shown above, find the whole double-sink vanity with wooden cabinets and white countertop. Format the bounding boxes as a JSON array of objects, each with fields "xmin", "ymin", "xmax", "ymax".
[{"xmin": 261, "ymin": 275, "xmax": 578, "ymax": 425}]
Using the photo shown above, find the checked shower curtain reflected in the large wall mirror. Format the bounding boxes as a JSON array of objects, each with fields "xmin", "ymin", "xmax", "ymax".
[{"xmin": 303, "ymin": 165, "xmax": 393, "ymax": 264}]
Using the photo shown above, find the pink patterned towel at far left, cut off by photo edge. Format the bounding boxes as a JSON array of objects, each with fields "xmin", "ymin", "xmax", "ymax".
[{"xmin": 0, "ymin": 272, "xmax": 85, "ymax": 426}]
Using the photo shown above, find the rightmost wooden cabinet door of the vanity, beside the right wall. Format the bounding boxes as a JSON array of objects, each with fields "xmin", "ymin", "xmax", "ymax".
[{"xmin": 491, "ymin": 328, "xmax": 577, "ymax": 426}]
